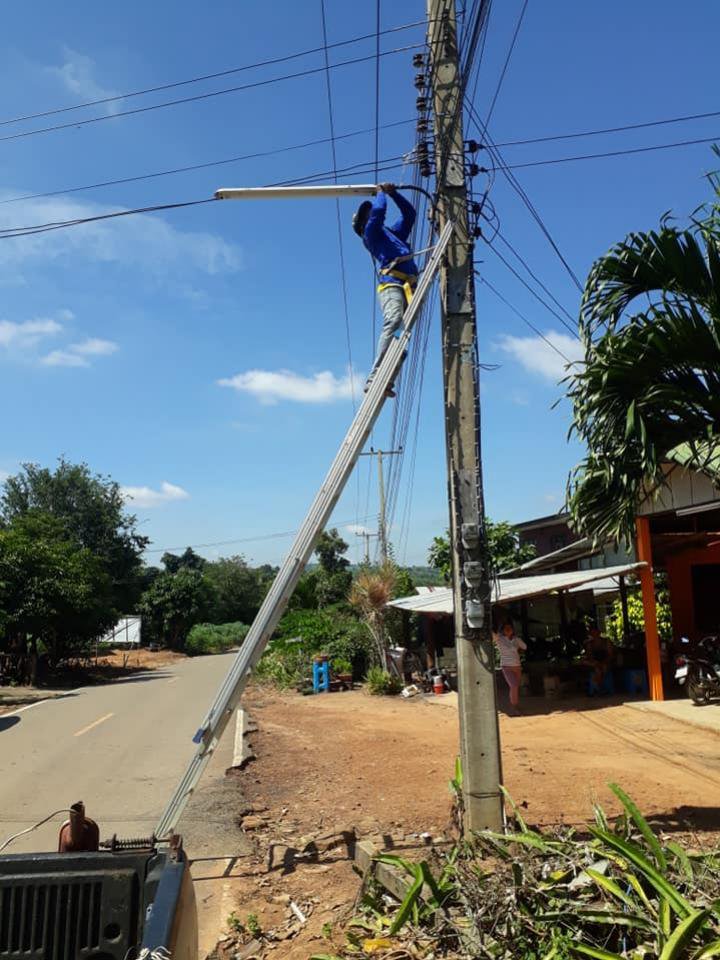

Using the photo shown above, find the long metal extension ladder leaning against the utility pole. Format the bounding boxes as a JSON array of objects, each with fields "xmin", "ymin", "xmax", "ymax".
[{"xmin": 155, "ymin": 222, "xmax": 454, "ymax": 839}]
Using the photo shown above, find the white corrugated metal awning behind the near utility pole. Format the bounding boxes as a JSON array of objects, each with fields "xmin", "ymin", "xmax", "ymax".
[{"xmin": 388, "ymin": 563, "xmax": 645, "ymax": 613}]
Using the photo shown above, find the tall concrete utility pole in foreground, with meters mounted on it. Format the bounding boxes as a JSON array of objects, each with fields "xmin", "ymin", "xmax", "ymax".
[{"xmin": 428, "ymin": 0, "xmax": 503, "ymax": 830}]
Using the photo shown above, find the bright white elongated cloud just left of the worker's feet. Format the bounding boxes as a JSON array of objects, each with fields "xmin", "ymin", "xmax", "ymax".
[{"xmin": 217, "ymin": 370, "xmax": 360, "ymax": 404}]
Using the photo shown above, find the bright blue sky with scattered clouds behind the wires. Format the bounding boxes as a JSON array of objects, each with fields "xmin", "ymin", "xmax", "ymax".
[{"xmin": 0, "ymin": 0, "xmax": 720, "ymax": 563}]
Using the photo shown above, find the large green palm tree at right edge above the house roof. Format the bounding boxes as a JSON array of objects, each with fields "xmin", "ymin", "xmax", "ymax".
[{"xmin": 566, "ymin": 163, "xmax": 720, "ymax": 541}]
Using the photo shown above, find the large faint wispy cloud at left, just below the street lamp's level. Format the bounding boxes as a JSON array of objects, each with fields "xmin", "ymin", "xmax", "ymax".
[{"xmin": 0, "ymin": 190, "xmax": 242, "ymax": 276}]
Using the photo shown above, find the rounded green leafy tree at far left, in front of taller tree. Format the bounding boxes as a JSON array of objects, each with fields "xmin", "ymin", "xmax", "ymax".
[{"xmin": 0, "ymin": 510, "xmax": 118, "ymax": 682}]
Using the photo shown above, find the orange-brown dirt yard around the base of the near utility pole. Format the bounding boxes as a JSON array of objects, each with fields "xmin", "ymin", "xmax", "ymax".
[{"xmin": 211, "ymin": 688, "xmax": 720, "ymax": 960}]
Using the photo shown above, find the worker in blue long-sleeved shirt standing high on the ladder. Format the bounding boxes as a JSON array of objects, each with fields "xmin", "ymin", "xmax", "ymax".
[{"xmin": 352, "ymin": 183, "xmax": 418, "ymax": 397}]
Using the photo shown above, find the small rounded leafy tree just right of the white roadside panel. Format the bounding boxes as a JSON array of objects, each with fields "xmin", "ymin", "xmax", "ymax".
[{"xmin": 138, "ymin": 567, "xmax": 215, "ymax": 650}]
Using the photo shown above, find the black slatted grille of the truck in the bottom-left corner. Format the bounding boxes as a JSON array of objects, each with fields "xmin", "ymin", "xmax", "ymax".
[{"xmin": 0, "ymin": 877, "xmax": 102, "ymax": 960}]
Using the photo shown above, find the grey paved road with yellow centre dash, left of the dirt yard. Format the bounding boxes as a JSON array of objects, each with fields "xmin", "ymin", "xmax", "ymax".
[{"xmin": 0, "ymin": 654, "xmax": 242, "ymax": 858}]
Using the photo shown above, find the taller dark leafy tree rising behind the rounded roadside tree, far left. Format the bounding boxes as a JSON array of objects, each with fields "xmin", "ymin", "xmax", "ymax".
[{"xmin": 0, "ymin": 458, "xmax": 149, "ymax": 612}]
